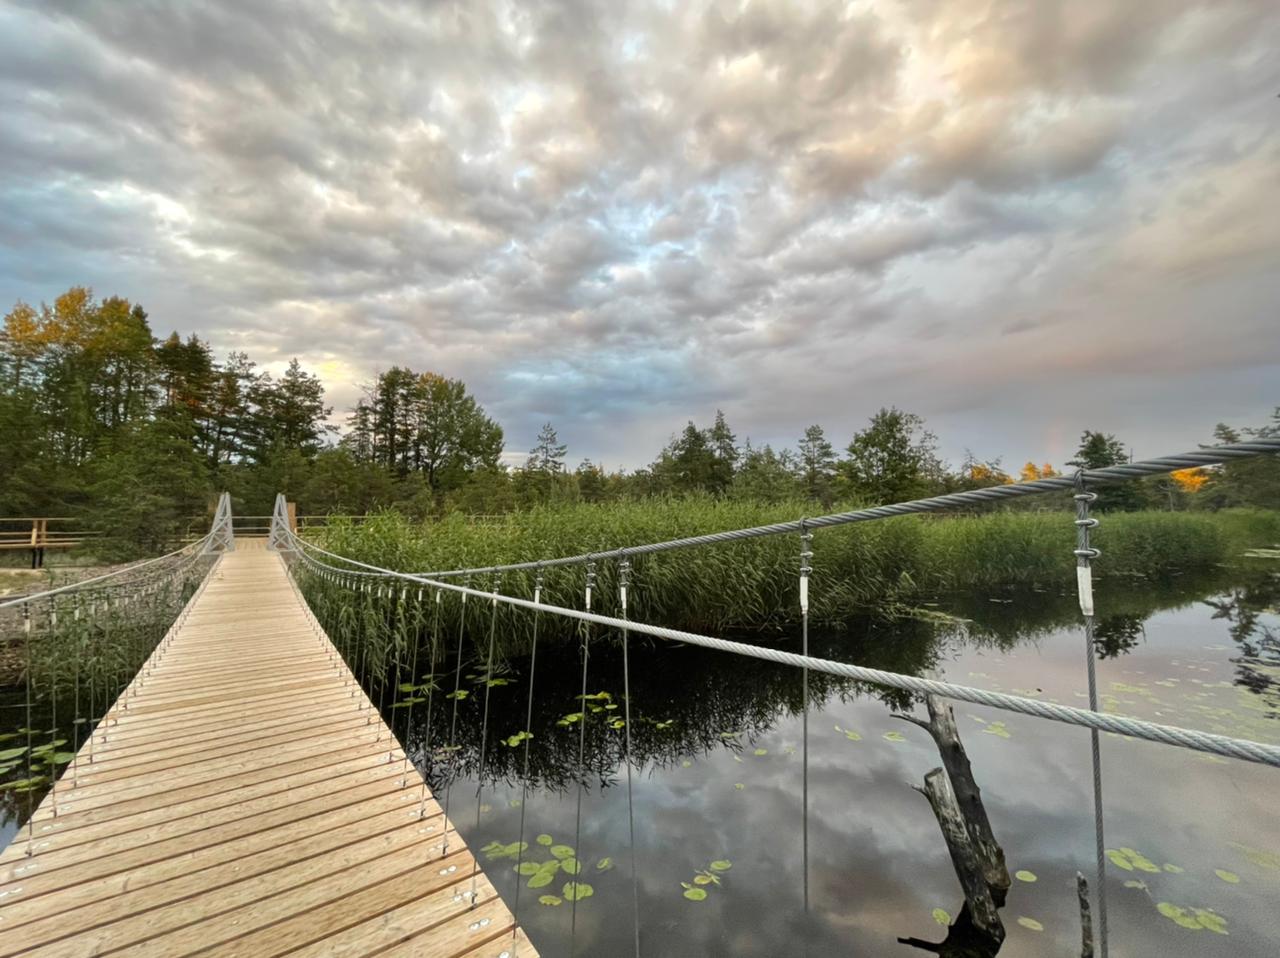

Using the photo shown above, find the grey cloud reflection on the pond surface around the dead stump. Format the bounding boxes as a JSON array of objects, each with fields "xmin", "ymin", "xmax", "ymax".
[{"xmin": 465, "ymin": 594, "xmax": 1280, "ymax": 958}]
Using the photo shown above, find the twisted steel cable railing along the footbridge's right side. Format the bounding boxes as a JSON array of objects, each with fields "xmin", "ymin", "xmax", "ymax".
[{"xmin": 269, "ymin": 438, "xmax": 1280, "ymax": 958}]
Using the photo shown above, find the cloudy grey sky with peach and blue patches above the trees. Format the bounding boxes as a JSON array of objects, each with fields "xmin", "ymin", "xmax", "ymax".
[{"xmin": 0, "ymin": 0, "xmax": 1280, "ymax": 466}]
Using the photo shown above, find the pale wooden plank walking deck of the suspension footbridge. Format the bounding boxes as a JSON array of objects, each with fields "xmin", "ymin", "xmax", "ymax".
[{"xmin": 0, "ymin": 539, "xmax": 536, "ymax": 958}]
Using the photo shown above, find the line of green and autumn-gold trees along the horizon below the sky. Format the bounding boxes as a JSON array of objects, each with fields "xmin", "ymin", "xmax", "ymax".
[{"xmin": 0, "ymin": 287, "xmax": 1280, "ymax": 549}]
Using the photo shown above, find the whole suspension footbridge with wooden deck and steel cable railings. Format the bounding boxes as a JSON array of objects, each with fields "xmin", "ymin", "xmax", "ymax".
[{"xmin": 0, "ymin": 439, "xmax": 1280, "ymax": 958}]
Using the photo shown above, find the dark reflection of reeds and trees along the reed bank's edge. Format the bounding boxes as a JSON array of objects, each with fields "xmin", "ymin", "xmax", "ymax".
[{"xmin": 335, "ymin": 568, "xmax": 1254, "ymax": 789}]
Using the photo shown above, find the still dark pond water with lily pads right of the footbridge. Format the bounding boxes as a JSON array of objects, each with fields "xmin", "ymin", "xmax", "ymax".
[{"xmin": 396, "ymin": 564, "xmax": 1280, "ymax": 958}]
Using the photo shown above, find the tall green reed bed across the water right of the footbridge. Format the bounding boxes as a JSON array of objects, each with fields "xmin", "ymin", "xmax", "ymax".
[{"xmin": 314, "ymin": 499, "xmax": 1280, "ymax": 647}]
